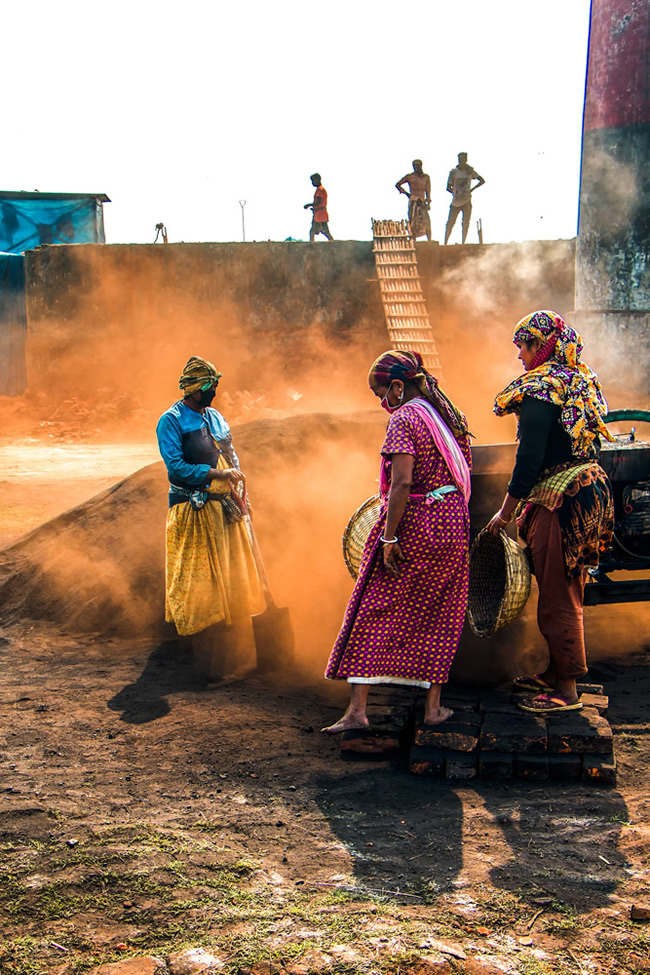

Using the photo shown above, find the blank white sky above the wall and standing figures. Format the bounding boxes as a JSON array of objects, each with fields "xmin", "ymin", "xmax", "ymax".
[{"xmin": 5, "ymin": 0, "xmax": 589, "ymax": 243}]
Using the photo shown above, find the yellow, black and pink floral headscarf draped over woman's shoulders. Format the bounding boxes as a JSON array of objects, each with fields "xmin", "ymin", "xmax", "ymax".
[{"xmin": 494, "ymin": 311, "xmax": 614, "ymax": 459}]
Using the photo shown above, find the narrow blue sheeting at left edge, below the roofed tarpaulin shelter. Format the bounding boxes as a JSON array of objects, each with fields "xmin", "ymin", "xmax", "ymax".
[{"xmin": 0, "ymin": 253, "xmax": 27, "ymax": 396}]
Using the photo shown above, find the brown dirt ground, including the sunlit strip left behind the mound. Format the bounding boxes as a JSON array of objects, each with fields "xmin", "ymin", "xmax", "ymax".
[{"xmin": 0, "ymin": 444, "xmax": 650, "ymax": 975}]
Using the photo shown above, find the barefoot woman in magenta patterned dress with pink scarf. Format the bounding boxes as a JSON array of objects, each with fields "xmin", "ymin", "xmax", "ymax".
[{"xmin": 323, "ymin": 350, "xmax": 471, "ymax": 734}]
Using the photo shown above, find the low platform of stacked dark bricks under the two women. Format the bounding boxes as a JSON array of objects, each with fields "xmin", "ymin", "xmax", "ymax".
[{"xmin": 341, "ymin": 684, "xmax": 616, "ymax": 786}]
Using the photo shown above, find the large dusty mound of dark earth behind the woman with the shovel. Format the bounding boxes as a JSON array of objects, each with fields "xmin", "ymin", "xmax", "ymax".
[{"xmin": 0, "ymin": 412, "xmax": 385, "ymax": 648}]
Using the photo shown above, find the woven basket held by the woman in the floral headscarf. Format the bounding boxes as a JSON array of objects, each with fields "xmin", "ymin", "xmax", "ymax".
[{"xmin": 467, "ymin": 528, "xmax": 530, "ymax": 637}]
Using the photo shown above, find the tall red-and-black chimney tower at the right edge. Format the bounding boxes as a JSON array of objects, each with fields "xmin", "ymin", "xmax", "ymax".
[{"xmin": 576, "ymin": 0, "xmax": 650, "ymax": 404}]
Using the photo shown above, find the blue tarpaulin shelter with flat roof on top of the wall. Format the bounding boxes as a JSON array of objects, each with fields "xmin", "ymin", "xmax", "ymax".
[{"xmin": 0, "ymin": 191, "xmax": 109, "ymax": 254}]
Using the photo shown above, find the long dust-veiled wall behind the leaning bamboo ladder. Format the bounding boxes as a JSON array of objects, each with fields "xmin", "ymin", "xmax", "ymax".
[{"xmin": 26, "ymin": 241, "xmax": 575, "ymax": 416}]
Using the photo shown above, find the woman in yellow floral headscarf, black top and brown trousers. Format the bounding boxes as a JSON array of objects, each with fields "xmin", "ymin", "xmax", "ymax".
[{"xmin": 488, "ymin": 311, "xmax": 613, "ymax": 714}]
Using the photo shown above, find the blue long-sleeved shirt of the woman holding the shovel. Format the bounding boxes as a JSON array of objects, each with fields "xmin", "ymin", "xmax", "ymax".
[{"xmin": 156, "ymin": 400, "xmax": 239, "ymax": 488}]
